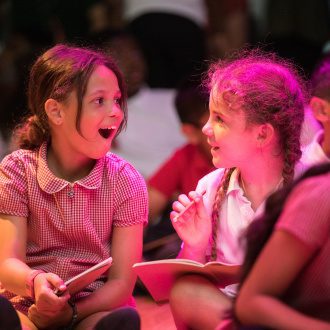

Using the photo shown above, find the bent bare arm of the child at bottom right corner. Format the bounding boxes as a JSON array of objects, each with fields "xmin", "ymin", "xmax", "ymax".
[{"xmin": 235, "ymin": 230, "xmax": 330, "ymax": 330}]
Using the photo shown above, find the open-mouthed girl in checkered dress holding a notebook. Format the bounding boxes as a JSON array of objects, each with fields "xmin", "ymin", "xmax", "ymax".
[{"xmin": 0, "ymin": 45, "xmax": 148, "ymax": 329}]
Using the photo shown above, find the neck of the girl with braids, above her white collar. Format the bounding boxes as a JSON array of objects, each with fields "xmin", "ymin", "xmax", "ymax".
[{"xmin": 240, "ymin": 153, "xmax": 283, "ymax": 210}]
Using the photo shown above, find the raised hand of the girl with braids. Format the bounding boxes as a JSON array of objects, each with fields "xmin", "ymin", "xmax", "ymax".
[{"xmin": 170, "ymin": 191, "xmax": 212, "ymax": 250}]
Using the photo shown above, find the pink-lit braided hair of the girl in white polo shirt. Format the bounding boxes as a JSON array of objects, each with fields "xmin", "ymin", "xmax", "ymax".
[{"xmin": 204, "ymin": 50, "xmax": 307, "ymax": 260}]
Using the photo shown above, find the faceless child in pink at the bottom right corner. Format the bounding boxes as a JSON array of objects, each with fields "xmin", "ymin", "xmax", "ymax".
[{"xmin": 233, "ymin": 163, "xmax": 330, "ymax": 330}]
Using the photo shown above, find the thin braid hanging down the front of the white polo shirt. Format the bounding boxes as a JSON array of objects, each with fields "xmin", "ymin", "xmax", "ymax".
[{"xmin": 210, "ymin": 167, "xmax": 235, "ymax": 261}]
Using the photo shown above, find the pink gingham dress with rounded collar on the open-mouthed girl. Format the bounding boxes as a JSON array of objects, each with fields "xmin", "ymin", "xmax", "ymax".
[{"xmin": 0, "ymin": 143, "xmax": 148, "ymax": 313}]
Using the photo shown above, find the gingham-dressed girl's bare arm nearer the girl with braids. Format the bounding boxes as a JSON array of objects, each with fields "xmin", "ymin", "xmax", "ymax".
[{"xmin": 73, "ymin": 224, "xmax": 143, "ymax": 320}]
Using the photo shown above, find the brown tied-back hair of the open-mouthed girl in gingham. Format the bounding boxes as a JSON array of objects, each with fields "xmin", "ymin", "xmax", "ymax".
[{"xmin": 14, "ymin": 44, "xmax": 127, "ymax": 150}]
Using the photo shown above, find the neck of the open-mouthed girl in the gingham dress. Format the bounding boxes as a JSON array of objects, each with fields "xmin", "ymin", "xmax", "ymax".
[{"xmin": 47, "ymin": 144, "xmax": 95, "ymax": 182}]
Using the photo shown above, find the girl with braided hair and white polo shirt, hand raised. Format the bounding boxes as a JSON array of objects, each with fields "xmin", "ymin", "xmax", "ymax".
[{"xmin": 170, "ymin": 50, "xmax": 306, "ymax": 329}]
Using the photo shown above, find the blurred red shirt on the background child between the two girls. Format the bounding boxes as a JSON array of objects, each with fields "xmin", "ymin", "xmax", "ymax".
[{"xmin": 148, "ymin": 144, "xmax": 215, "ymax": 198}]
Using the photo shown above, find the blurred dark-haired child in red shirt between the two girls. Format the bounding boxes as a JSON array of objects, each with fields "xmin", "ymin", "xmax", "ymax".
[{"xmin": 144, "ymin": 76, "xmax": 214, "ymax": 259}]
